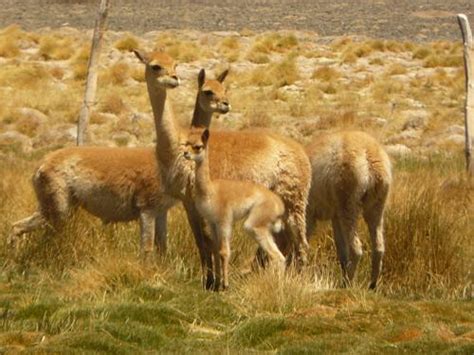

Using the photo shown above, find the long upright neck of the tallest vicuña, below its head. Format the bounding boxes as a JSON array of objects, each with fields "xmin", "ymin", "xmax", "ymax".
[{"xmin": 147, "ymin": 82, "xmax": 179, "ymax": 167}]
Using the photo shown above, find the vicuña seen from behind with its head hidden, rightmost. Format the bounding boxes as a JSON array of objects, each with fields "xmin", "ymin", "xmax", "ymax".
[{"xmin": 306, "ymin": 131, "xmax": 392, "ymax": 289}]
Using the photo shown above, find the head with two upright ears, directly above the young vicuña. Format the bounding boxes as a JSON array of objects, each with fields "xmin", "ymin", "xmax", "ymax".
[{"xmin": 197, "ymin": 69, "xmax": 230, "ymax": 113}]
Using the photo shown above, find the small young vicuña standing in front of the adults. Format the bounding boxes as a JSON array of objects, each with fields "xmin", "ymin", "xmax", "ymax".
[{"xmin": 184, "ymin": 128, "xmax": 285, "ymax": 291}]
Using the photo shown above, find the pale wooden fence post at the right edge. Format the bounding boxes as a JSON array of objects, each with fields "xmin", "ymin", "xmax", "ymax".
[{"xmin": 457, "ymin": 14, "xmax": 474, "ymax": 178}]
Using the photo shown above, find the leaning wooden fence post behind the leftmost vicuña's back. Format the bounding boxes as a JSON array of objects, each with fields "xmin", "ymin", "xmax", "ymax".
[{"xmin": 77, "ymin": 0, "xmax": 109, "ymax": 145}]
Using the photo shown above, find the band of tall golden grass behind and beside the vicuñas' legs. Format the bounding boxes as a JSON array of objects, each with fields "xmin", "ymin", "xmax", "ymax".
[{"xmin": 0, "ymin": 157, "xmax": 474, "ymax": 298}]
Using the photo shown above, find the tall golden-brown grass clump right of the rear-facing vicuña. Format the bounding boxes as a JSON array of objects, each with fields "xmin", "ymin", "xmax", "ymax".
[{"xmin": 384, "ymin": 170, "xmax": 474, "ymax": 293}]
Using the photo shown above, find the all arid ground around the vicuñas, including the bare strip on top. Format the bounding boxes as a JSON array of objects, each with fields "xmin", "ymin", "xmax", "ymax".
[{"xmin": 0, "ymin": 0, "xmax": 474, "ymax": 354}]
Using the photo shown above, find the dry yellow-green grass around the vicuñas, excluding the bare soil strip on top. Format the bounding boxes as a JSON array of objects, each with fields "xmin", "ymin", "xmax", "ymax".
[{"xmin": 0, "ymin": 28, "xmax": 474, "ymax": 353}]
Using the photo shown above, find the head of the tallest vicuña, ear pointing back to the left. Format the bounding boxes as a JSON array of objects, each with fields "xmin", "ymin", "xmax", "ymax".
[{"xmin": 133, "ymin": 49, "xmax": 179, "ymax": 89}]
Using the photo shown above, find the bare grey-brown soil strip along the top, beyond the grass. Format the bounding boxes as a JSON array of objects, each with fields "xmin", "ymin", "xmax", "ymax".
[{"xmin": 0, "ymin": 0, "xmax": 474, "ymax": 41}]
